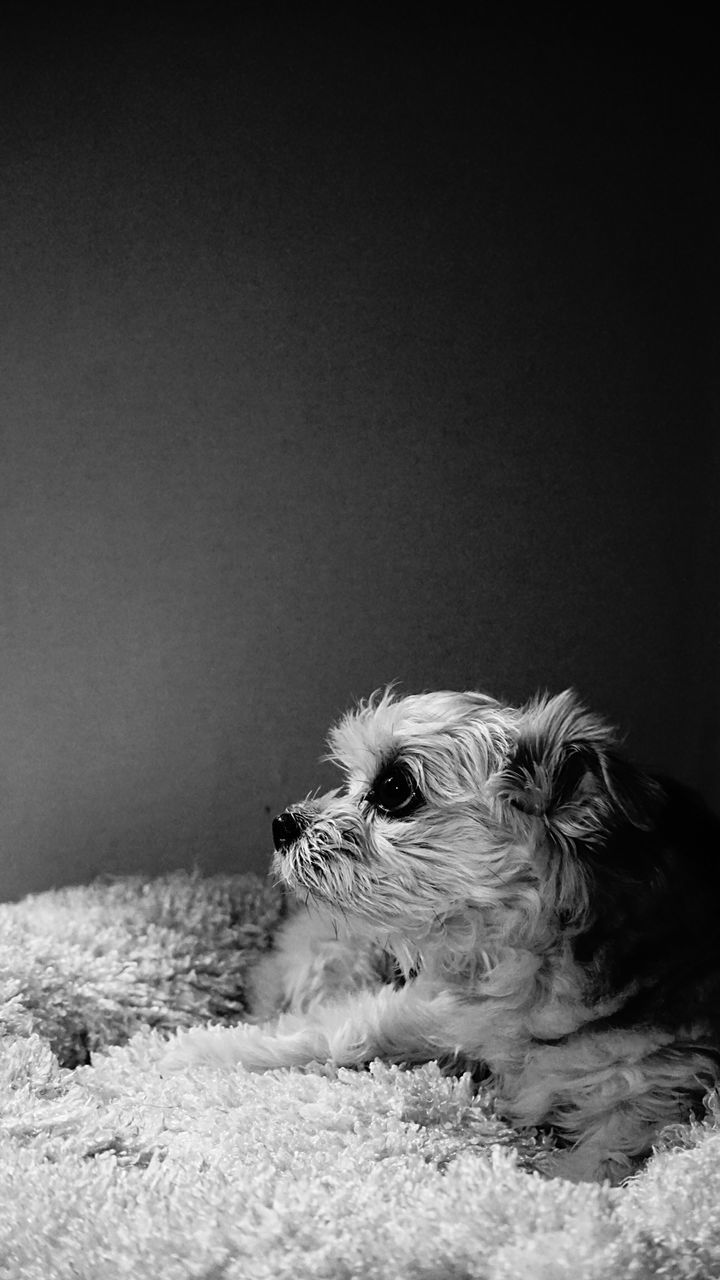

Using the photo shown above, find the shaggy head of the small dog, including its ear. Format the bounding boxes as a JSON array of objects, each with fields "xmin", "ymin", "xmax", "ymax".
[{"xmin": 267, "ymin": 692, "xmax": 655, "ymax": 962}]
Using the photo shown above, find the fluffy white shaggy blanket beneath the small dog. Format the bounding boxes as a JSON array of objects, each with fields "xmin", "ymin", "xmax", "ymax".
[{"xmin": 0, "ymin": 874, "xmax": 720, "ymax": 1280}]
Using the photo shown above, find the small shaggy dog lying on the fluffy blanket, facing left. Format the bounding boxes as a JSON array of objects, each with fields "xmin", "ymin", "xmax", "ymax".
[{"xmin": 165, "ymin": 687, "xmax": 720, "ymax": 1184}]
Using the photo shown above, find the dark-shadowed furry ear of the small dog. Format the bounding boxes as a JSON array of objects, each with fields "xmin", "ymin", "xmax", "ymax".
[{"xmin": 492, "ymin": 690, "xmax": 656, "ymax": 841}]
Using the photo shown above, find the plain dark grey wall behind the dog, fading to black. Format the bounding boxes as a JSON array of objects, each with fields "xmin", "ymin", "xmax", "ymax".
[{"xmin": 0, "ymin": 17, "xmax": 720, "ymax": 897}]
